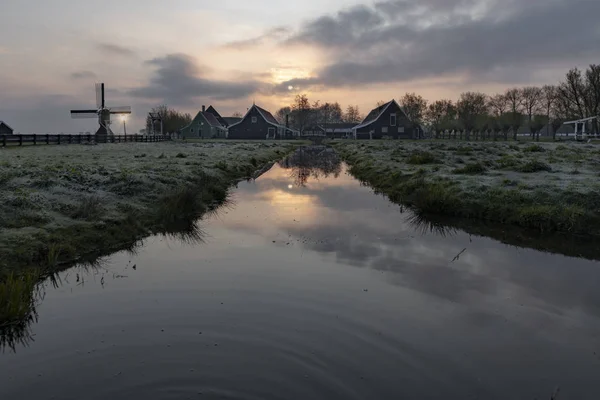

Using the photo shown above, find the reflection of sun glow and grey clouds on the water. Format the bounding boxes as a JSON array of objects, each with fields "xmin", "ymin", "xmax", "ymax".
[{"xmin": 227, "ymin": 161, "xmax": 600, "ymax": 315}]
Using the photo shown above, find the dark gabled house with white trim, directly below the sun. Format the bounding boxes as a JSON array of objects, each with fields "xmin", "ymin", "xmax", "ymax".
[{"xmin": 227, "ymin": 104, "xmax": 296, "ymax": 139}]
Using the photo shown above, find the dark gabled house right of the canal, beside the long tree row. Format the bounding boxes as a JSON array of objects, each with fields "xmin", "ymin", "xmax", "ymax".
[{"xmin": 352, "ymin": 100, "xmax": 419, "ymax": 139}]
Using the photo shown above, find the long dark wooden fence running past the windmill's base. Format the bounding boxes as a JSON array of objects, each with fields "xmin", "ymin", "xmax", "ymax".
[{"xmin": 0, "ymin": 134, "xmax": 171, "ymax": 147}]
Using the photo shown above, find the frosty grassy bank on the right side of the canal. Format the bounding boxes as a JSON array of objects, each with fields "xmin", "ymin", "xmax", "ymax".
[{"xmin": 334, "ymin": 141, "xmax": 600, "ymax": 235}]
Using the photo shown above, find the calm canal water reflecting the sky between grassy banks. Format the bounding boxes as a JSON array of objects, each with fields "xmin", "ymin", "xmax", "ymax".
[{"xmin": 0, "ymin": 150, "xmax": 600, "ymax": 400}]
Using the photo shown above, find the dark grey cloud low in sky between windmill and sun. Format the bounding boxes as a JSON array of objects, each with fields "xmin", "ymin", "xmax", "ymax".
[{"xmin": 130, "ymin": 54, "xmax": 259, "ymax": 105}]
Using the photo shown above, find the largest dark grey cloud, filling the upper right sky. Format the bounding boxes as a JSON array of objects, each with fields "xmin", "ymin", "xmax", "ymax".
[{"xmin": 277, "ymin": 0, "xmax": 600, "ymax": 91}]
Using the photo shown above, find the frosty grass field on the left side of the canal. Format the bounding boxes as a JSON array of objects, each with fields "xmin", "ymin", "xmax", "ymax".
[{"xmin": 0, "ymin": 141, "xmax": 300, "ymax": 277}]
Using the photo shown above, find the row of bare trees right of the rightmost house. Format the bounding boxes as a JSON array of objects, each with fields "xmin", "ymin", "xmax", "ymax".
[{"xmin": 400, "ymin": 65, "xmax": 600, "ymax": 140}]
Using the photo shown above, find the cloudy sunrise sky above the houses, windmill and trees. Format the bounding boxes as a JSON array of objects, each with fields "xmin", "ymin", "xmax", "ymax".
[{"xmin": 0, "ymin": 0, "xmax": 600, "ymax": 133}]
